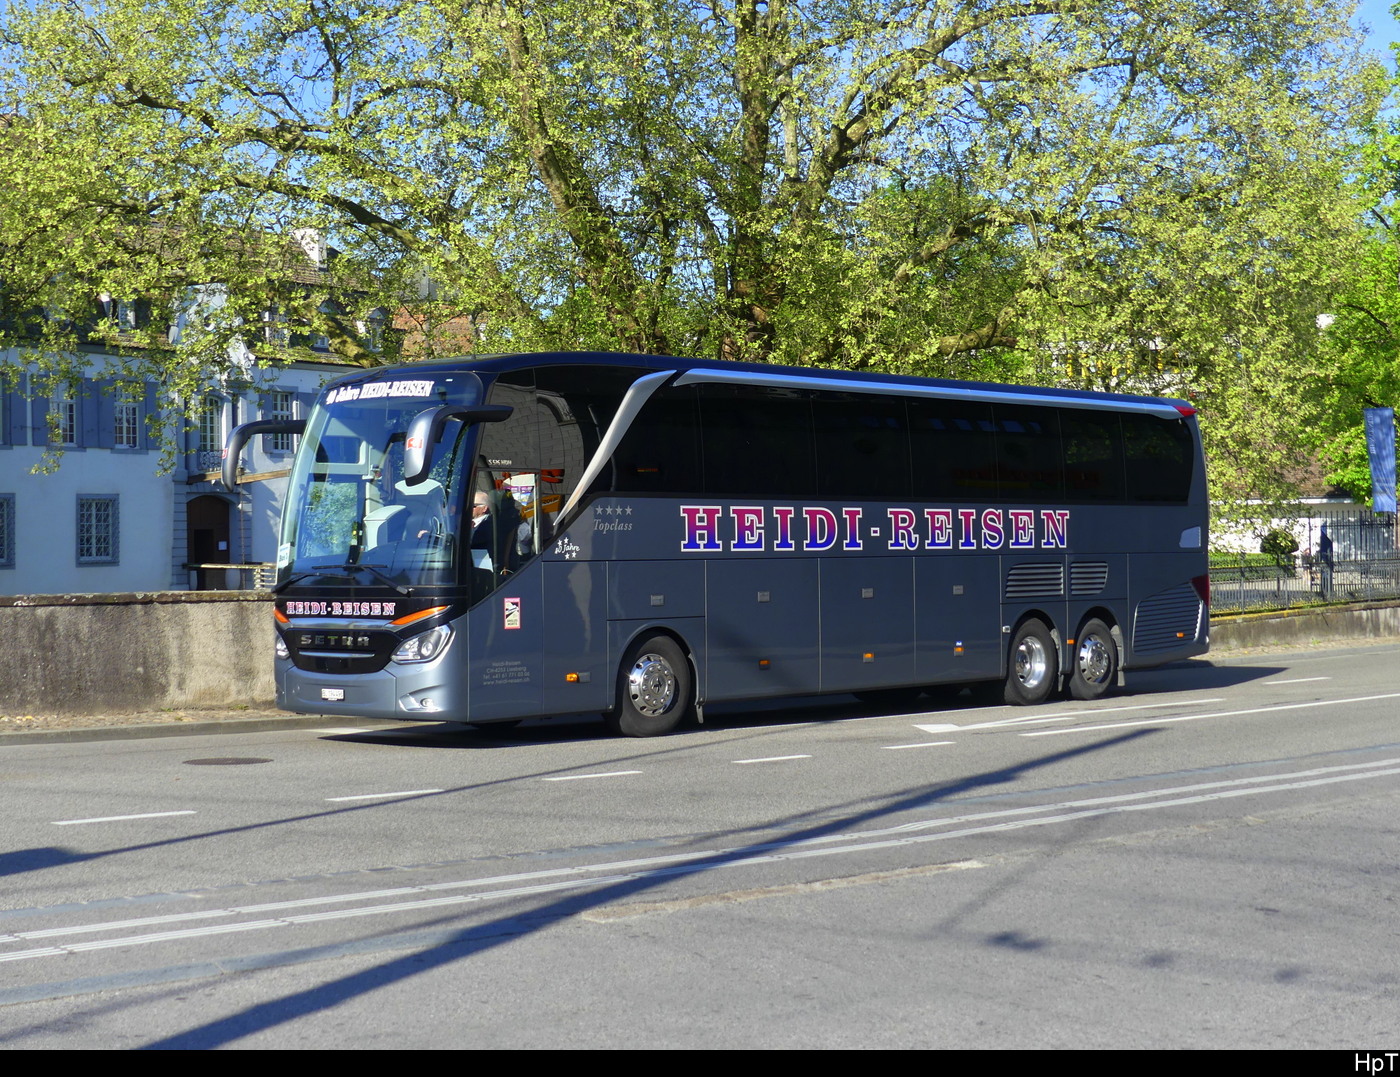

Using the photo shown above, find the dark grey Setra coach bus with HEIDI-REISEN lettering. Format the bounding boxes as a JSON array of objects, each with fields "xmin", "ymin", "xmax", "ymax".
[{"xmin": 224, "ymin": 353, "xmax": 1210, "ymax": 737}]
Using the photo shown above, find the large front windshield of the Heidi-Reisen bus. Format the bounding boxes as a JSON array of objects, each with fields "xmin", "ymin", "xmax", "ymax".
[{"xmin": 277, "ymin": 371, "xmax": 482, "ymax": 590}]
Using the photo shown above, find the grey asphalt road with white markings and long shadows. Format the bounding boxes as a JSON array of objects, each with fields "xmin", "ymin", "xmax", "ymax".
[{"xmin": 0, "ymin": 644, "xmax": 1400, "ymax": 1048}]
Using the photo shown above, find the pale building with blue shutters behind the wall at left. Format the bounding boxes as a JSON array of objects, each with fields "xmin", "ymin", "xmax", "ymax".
[{"xmin": 0, "ymin": 352, "xmax": 346, "ymax": 595}]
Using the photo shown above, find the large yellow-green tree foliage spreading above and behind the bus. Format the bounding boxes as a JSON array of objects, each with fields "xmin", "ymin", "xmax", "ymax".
[{"xmin": 0, "ymin": 0, "xmax": 1368, "ymax": 496}]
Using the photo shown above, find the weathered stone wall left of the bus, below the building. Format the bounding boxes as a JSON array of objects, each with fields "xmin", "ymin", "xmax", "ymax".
[{"xmin": 0, "ymin": 591, "xmax": 274, "ymax": 714}]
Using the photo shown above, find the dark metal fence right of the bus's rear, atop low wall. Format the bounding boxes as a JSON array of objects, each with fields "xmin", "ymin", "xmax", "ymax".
[{"xmin": 1211, "ymin": 511, "xmax": 1400, "ymax": 613}]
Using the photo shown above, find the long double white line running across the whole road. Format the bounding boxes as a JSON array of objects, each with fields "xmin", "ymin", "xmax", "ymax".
[{"xmin": 10, "ymin": 750, "xmax": 1400, "ymax": 962}]
